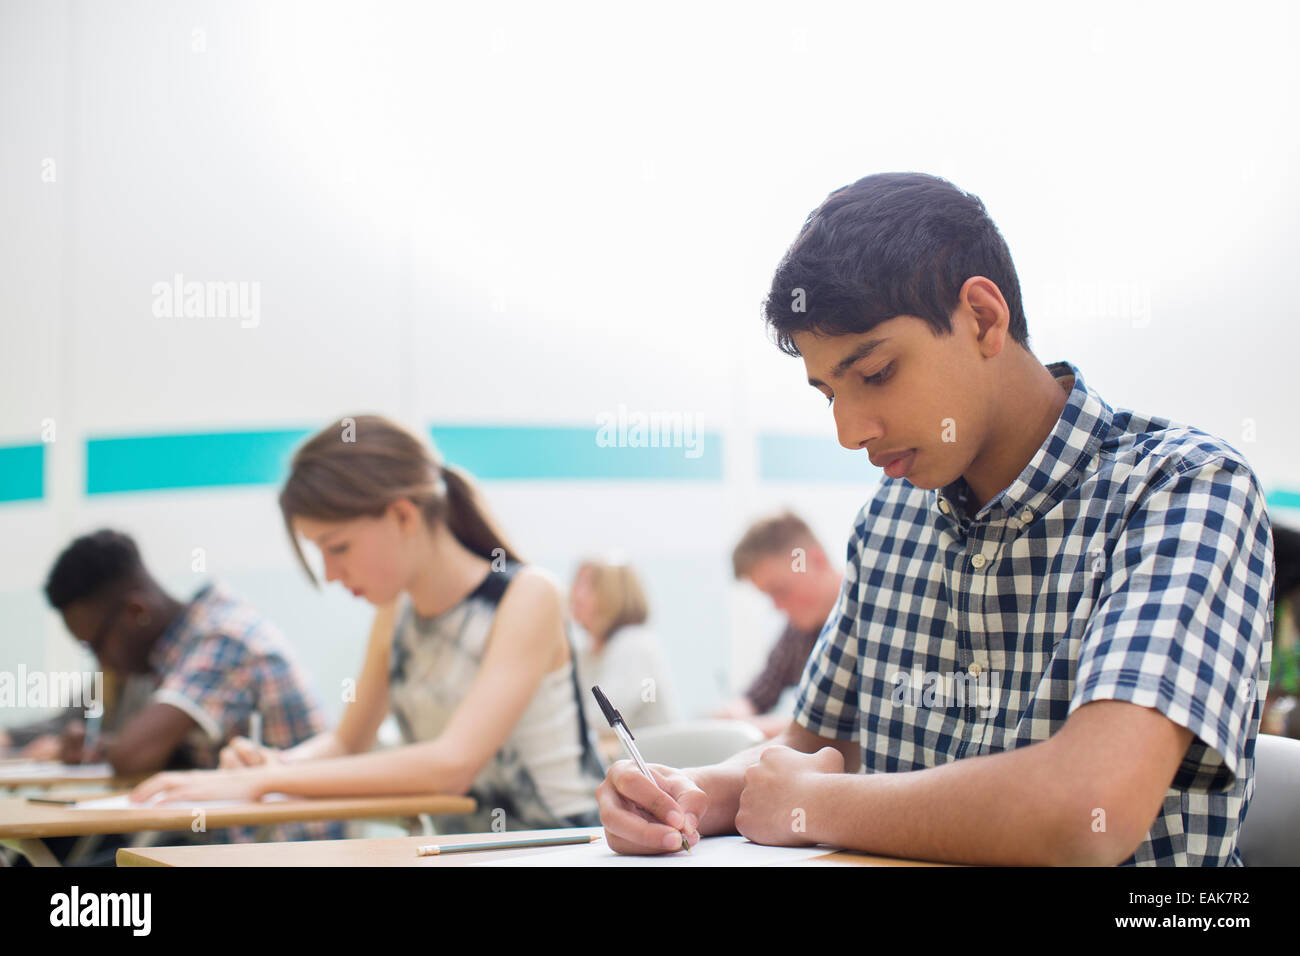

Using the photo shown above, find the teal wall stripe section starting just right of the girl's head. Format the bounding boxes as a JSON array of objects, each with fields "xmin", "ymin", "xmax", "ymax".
[{"xmin": 430, "ymin": 425, "xmax": 723, "ymax": 481}]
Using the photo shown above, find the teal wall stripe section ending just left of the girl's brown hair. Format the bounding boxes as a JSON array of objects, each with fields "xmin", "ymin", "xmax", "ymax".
[{"xmin": 86, "ymin": 429, "xmax": 308, "ymax": 494}]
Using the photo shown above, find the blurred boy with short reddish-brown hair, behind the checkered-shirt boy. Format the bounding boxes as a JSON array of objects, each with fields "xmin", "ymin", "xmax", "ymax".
[{"xmin": 714, "ymin": 511, "xmax": 842, "ymax": 736}]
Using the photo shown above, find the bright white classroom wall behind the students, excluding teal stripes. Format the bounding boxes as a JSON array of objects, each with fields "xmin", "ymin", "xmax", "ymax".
[{"xmin": 0, "ymin": 0, "xmax": 1300, "ymax": 722}]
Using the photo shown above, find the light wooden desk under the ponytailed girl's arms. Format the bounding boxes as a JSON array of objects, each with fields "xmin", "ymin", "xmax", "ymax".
[{"xmin": 0, "ymin": 793, "xmax": 476, "ymax": 866}]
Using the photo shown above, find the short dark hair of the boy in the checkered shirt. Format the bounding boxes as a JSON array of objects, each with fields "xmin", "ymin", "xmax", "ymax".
[{"xmin": 763, "ymin": 173, "xmax": 1030, "ymax": 355}]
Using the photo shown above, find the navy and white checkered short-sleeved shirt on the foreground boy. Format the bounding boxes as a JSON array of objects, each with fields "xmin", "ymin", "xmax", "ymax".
[{"xmin": 794, "ymin": 362, "xmax": 1273, "ymax": 866}]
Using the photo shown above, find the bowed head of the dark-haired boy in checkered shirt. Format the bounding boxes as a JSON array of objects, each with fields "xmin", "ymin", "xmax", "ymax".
[{"xmin": 763, "ymin": 173, "xmax": 1028, "ymax": 488}]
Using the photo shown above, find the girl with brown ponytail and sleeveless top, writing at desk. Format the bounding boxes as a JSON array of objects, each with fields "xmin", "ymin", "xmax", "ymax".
[{"xmin": 133, "ymin": 415, "xmax": 605, "ymax": 832}]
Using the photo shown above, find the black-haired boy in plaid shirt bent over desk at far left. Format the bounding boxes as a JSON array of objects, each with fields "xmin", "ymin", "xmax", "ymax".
[{"xmin": 46, "ymin": 529, "xmax": 343, "ymax": 843}]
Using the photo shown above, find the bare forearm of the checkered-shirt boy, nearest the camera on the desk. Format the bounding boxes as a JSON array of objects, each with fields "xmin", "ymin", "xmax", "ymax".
[{"xmin": 806, "ymin": 744, "xmax": 1114, "ymax": 865}]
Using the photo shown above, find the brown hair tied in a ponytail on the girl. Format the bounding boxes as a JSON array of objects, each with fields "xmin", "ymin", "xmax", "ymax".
[{"xmin": 280, "ymin": 415, "xmax": 521, "ymax": 581}]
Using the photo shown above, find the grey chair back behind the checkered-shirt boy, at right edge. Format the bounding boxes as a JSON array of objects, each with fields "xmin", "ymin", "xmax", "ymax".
[{"xmin": 1236, "ymin": 734, "xmax": 1300, "ymax": 866}]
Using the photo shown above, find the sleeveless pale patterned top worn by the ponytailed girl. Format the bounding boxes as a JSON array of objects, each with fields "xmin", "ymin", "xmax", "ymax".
[{"xmin": 389, "ymin": 561, "xmax": 605, "ymax": 832}]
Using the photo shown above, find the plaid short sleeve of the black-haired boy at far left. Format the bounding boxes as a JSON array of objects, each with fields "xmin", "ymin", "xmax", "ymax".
[{"xmin": 153, "ymin": 633, "xmax": 255, "ymax": 745}]
